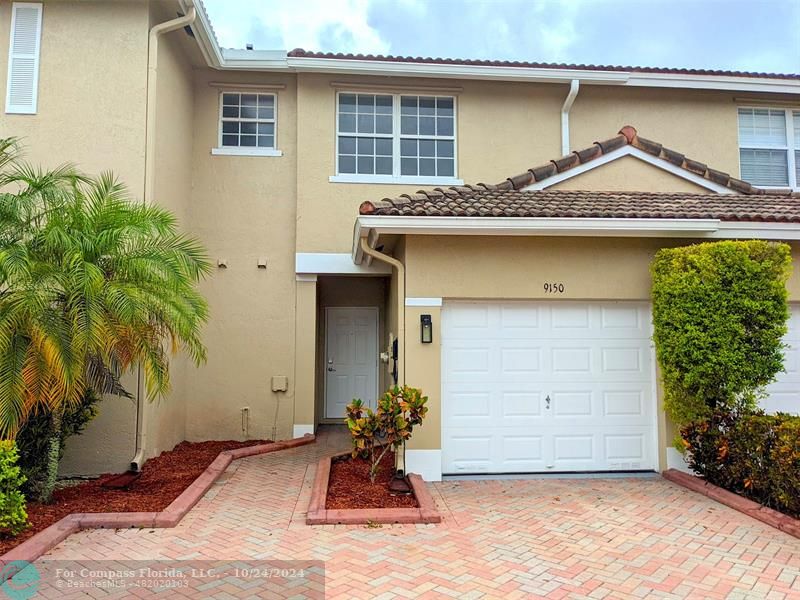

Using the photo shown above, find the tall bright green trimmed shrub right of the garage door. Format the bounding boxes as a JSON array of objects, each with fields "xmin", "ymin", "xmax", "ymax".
[{"xmin": 651, "ymin": 240, "xmax": 791, "ymax": 425}]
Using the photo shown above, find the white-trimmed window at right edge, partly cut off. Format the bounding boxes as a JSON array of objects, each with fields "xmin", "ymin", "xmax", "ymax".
[{"xmin": 739, "ymin": 108, "xmax": 800, "ymax": 188}]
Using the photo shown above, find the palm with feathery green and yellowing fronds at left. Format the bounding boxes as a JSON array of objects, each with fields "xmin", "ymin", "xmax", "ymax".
[{"xmin": 0, "ymin": 139, "xmax": 210, "ymax": 501}]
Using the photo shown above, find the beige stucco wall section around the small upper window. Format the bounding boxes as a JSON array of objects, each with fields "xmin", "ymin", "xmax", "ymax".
[{"xmin": 185, "ymin": 69, "xmax": 297, "ymax": 440}]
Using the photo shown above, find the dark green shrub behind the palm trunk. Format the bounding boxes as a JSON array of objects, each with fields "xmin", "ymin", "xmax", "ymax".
[{"xmin": 16, "ymin": 389, "xmax": 100, "ymax": 499}]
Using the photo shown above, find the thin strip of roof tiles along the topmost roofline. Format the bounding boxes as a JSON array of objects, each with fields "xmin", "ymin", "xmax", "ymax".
[{"xmin": 287, "ymin": 48, "xmax": 800, "ymax": 79}]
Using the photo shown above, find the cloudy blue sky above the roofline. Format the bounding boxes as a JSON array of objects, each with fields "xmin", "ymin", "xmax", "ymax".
[{"xmin": 204, "ymin": 0, "xmax": 800, "ymax": 73}]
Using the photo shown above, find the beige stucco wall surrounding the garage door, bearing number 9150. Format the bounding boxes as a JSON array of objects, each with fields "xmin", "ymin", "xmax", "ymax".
[{"xmin": 405, "ymin": 235, "xmax": 800, "ymax": 468}]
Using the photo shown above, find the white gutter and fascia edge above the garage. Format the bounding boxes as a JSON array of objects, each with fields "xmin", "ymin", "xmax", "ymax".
[{"xmin": 352, "ymin": 216, "xmax": 800, "ymax": 264}]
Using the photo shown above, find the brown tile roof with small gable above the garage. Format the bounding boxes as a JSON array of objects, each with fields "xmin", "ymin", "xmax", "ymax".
[{"xmin": 359, "ymin": 125, "xmax": 800, "ymax": 223}]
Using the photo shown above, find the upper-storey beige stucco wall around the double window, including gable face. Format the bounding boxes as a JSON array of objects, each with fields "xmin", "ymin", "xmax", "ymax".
[{"xmin": 297, "ymin": 74, "xmax": 764, "ymax": 252}]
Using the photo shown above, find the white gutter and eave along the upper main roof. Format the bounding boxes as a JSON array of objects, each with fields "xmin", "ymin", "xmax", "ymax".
[{"xmin": 178, "ymin": 0, "xmax": 800, "ymax": 94}]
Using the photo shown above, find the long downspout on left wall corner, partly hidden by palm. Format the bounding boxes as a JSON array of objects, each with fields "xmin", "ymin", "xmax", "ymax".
[{"xmin": 131, "ymin": 5, "xmax": 197, "ymax": 471}]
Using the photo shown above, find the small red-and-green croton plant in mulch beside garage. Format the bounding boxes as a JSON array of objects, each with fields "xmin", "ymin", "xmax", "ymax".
[{"xmin": 345, "ymin": 385, "xmax": 428, "ymax": 483}]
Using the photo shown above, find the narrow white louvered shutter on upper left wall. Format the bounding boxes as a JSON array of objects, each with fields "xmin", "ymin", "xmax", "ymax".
[{"xmin": 6, "ymin": 2, "xmax": 42, "ymax": 114}]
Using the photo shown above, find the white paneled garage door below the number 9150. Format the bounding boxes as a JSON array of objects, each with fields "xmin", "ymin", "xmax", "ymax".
[{"xmin": 442, "ymin": 301, "xmax": 657, "ymax": 474}]
